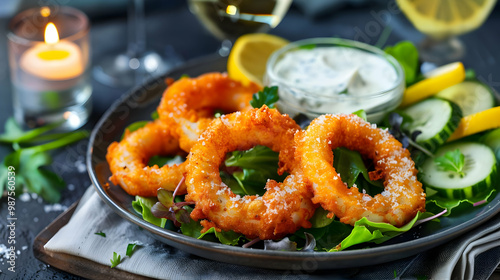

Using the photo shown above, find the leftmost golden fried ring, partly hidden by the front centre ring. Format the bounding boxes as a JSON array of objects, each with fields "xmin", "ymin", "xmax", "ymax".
[{"xmin": 106, "ymin": 120, "xmax": 187, "ymax": 196}]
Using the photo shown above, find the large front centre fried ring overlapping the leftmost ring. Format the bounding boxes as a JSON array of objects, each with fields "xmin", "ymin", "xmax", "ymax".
[{"xmin": 186, "ymin": 106, "xmax": 316, "ymax": 240}]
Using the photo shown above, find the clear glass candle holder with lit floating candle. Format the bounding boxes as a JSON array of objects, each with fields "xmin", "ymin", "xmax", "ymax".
[{"xmin": 7, "ymin": 6, "xmax": 92, "ymax": 130}]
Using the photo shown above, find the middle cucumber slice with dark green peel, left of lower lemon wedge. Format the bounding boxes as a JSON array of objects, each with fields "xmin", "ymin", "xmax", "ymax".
[{"xmin": 402, "ymin": 97, "xmax": 462, "ymax": 152}]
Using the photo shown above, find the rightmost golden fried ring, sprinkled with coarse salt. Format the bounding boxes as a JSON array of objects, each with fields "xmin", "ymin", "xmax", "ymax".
[{"xmin": 296, "ymin": 114, "xmax": 425, "ymax": 226}]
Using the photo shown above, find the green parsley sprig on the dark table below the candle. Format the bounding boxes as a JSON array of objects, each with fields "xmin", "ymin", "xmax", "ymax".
[{"xmin": 0, "ymin": 118, "xmax": 89, "ymax": 203}]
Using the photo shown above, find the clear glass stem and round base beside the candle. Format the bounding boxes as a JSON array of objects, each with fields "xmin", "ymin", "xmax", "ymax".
[{"xmin": 92, "ymin": 0, "xmax": 177, "ymax": 88}]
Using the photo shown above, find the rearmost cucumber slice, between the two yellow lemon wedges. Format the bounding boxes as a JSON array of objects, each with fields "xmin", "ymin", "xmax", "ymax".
[{"xmin": 436, "ymin": 81, "xmax": 495, "ymax": 116}]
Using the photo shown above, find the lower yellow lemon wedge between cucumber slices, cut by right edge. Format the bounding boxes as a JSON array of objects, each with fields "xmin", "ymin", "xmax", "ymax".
[{"xmin": 448, "ymin": 106, "xmax": 500, "ymax": 141}]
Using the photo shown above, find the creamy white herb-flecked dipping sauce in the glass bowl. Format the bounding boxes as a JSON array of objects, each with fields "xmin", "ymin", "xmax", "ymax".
[{"xmin": 275, "ymin": 47, "xmax": 397, "ymax": 96}]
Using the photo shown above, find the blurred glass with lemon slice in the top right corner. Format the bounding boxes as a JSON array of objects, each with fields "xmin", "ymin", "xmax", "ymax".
[{"xmin": 396, "ymin": 0, "xmax": 496, "ymax": 65}]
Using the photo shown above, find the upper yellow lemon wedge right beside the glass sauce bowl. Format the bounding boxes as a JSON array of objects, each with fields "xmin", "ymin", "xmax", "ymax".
[{"xmin": 400, "ymin": 62, "xmax": 465, "ymax": 107}]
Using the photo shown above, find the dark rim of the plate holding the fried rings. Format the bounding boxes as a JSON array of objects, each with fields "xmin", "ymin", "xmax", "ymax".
[{"xmin": 86, "ymin": 55, "xmax": 500, "ymax": 269}]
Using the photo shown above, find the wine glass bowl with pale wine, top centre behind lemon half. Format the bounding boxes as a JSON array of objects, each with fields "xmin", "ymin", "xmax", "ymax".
[{"xmin": 188, "ymin": 0, "xmax": 292, "ymax": 56}]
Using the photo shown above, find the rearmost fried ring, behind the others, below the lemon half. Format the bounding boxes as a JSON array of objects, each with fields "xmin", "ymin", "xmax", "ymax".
[{"xmin": 158, "ymin": 73, "xmax": 260, "ymax": 152}]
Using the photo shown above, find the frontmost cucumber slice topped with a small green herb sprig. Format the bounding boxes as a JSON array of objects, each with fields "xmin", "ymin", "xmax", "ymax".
[{"xmin": 420, "ymin": 142, "xmax": 498, "ymax": 199}]
